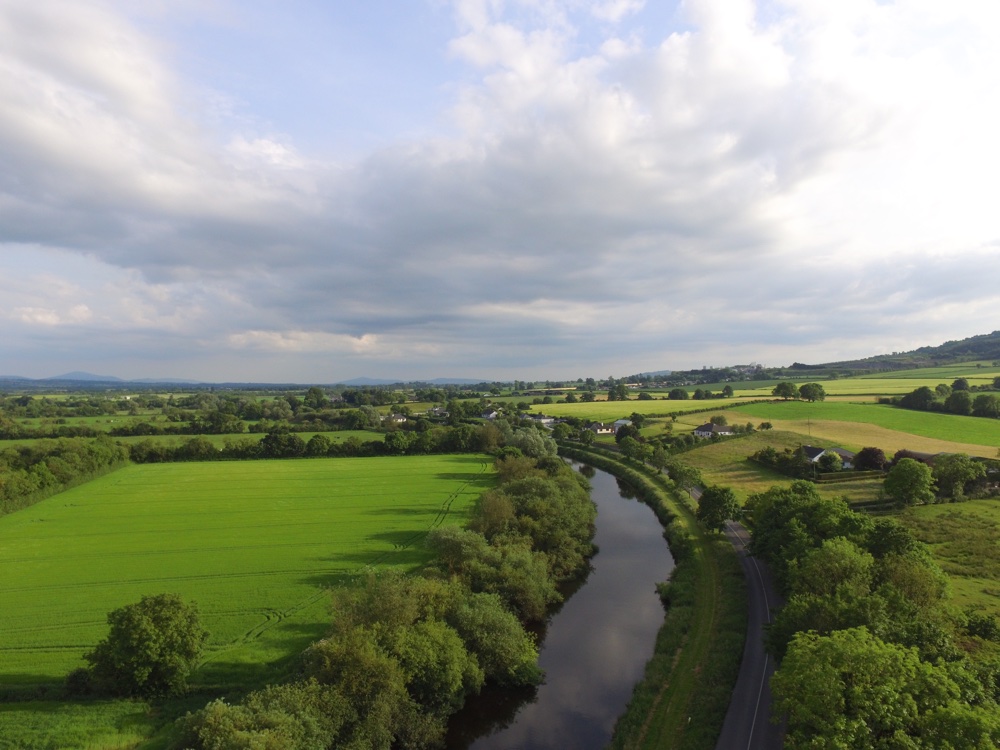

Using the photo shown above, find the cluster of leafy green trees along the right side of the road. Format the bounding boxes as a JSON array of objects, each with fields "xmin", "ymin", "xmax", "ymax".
[{"xmin": 746, "ymin": 481, "xmax": 1000, "ymax": 750}]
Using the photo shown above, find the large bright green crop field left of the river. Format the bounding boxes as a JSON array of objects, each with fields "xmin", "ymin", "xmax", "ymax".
[{"xmin": 0, "ymin": 456, "xmax": 492, "ymax": 683}]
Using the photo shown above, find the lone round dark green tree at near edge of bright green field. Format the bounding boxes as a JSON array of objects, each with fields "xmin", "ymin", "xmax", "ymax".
[{"xmin": 83, "ymin": 594, "xmax": 208, "ymax": 697}]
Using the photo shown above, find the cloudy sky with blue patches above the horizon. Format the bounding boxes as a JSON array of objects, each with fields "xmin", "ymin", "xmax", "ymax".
[{"xmin": 0, "ymin": 0, "xmax": 1000, "ymax": 383}]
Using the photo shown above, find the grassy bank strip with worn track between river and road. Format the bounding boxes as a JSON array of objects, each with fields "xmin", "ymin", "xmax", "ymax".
[{"xmin": 560, "ymin": 446, "xmax": 747, "ymax": 750}]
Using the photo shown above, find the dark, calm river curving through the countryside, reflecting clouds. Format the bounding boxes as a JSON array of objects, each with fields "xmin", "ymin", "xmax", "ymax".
[{"xmin": 448, "ymin": 471, "xmax": 674, "ymax": 750}]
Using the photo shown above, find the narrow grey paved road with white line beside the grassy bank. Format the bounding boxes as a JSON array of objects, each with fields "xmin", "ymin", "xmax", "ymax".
[{"xmin": 716, "ymin": 524, "xmax": 784, "ymax": 750}]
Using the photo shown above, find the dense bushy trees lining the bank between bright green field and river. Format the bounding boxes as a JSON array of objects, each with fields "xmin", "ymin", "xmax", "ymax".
[{"xmin": 176, "ymin": 456, "xmax": 596, "ymax": 750}]
